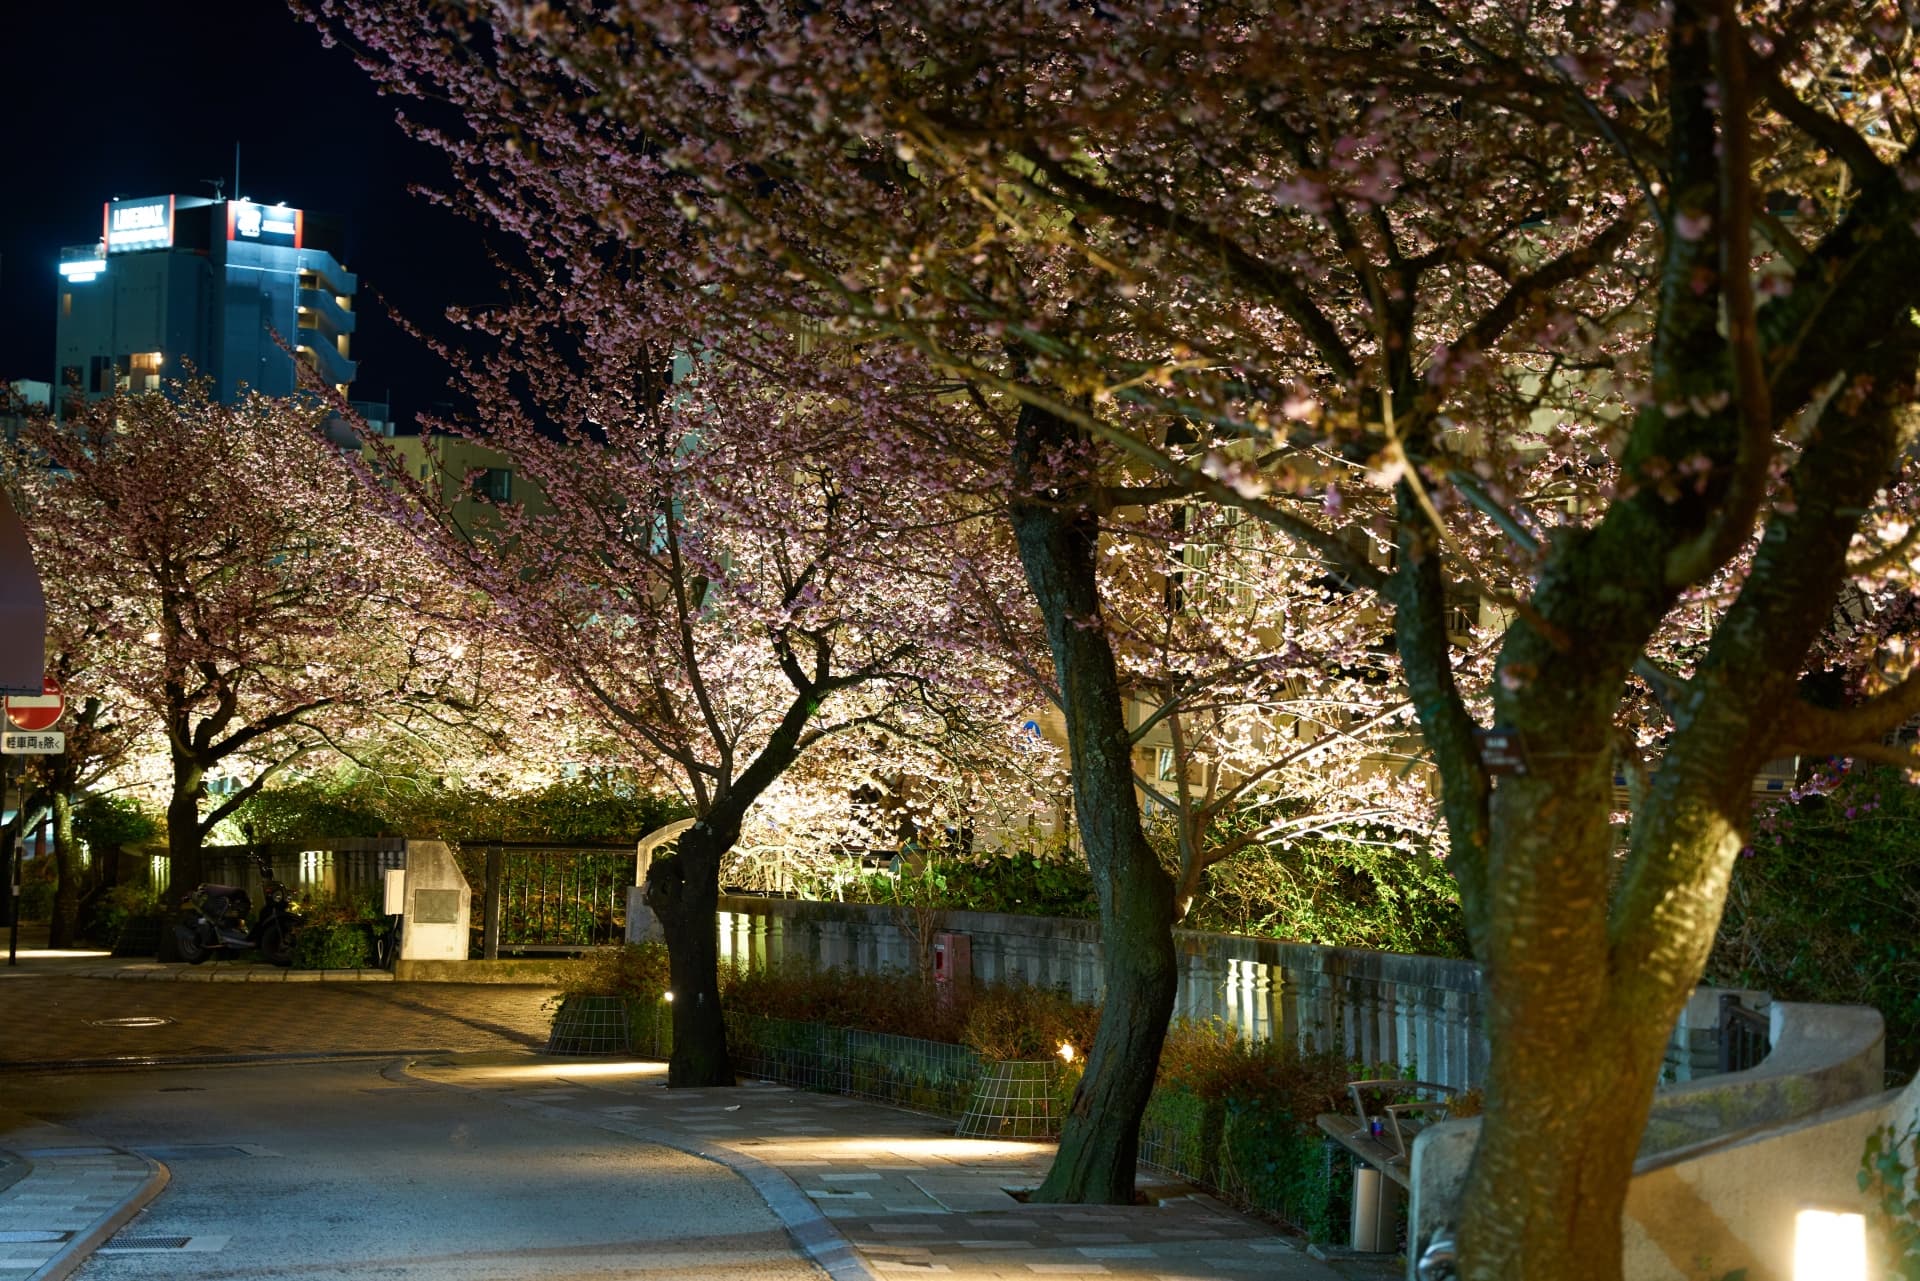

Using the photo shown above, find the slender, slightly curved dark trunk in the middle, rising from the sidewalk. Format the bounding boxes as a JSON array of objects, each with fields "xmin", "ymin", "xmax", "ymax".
[{"xmin": 1012, "ymin": 407, "xmax": 1177, "ymax": 1204}]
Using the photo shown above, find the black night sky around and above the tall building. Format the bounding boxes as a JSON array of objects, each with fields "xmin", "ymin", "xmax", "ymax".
[{"xmin": 0, "ymin": 0, "xmax": 495, "ymax": 424}]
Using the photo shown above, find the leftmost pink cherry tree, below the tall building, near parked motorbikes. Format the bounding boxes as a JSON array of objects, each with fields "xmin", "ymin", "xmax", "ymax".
[{"xmin": 12, "ymin": 391, "xmax": 470, "ymax": 902}]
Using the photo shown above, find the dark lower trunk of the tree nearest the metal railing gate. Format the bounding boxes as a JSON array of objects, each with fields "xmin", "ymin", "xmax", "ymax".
[{"xmin": 647, "ymin": 816, "xmax": 739, "ymax": 1087}]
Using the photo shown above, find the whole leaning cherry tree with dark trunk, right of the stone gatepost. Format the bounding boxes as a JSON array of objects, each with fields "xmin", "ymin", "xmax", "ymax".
[{"xmin": 349, "ymin": 286, "xmax": 1023, "ymax": 1085}]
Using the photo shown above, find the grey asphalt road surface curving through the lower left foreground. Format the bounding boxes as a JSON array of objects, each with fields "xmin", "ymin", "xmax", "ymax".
[{"xmin": 0, "ymin": 1062, "xmax": 822, "ymax": 1281}]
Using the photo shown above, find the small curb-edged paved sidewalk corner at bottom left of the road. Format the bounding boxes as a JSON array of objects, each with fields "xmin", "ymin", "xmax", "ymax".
[{"xmin": 0, "ymin": 1110, "xmax": 167, "ymax": 1281}]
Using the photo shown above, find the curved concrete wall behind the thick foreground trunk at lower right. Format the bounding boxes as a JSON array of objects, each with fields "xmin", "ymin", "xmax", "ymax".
[{"xmin": 1407, "ymin": 1001, "xmax": 1889, "ymax": 1281}]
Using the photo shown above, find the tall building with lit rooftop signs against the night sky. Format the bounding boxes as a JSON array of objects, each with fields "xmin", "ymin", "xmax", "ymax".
[{"xmin": 54, "ymin": 196, "xmax": 359, "ymax": 412}]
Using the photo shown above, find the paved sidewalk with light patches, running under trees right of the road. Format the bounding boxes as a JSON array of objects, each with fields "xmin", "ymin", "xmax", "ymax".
[{"xmin": 407, "ymin": 1054, "xmax": 1394, "ymax": 1281}]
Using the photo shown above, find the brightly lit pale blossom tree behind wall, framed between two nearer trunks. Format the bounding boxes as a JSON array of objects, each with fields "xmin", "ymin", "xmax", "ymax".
[{"xmin": 1100, "ymin": 501, "xmax": 1443, "ymax": 916}]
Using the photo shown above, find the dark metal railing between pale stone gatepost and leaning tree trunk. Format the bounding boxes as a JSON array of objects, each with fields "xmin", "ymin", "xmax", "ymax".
[{"xmin": 455, "ymin": 841, "xmax": 634, "ymax": 958}]
